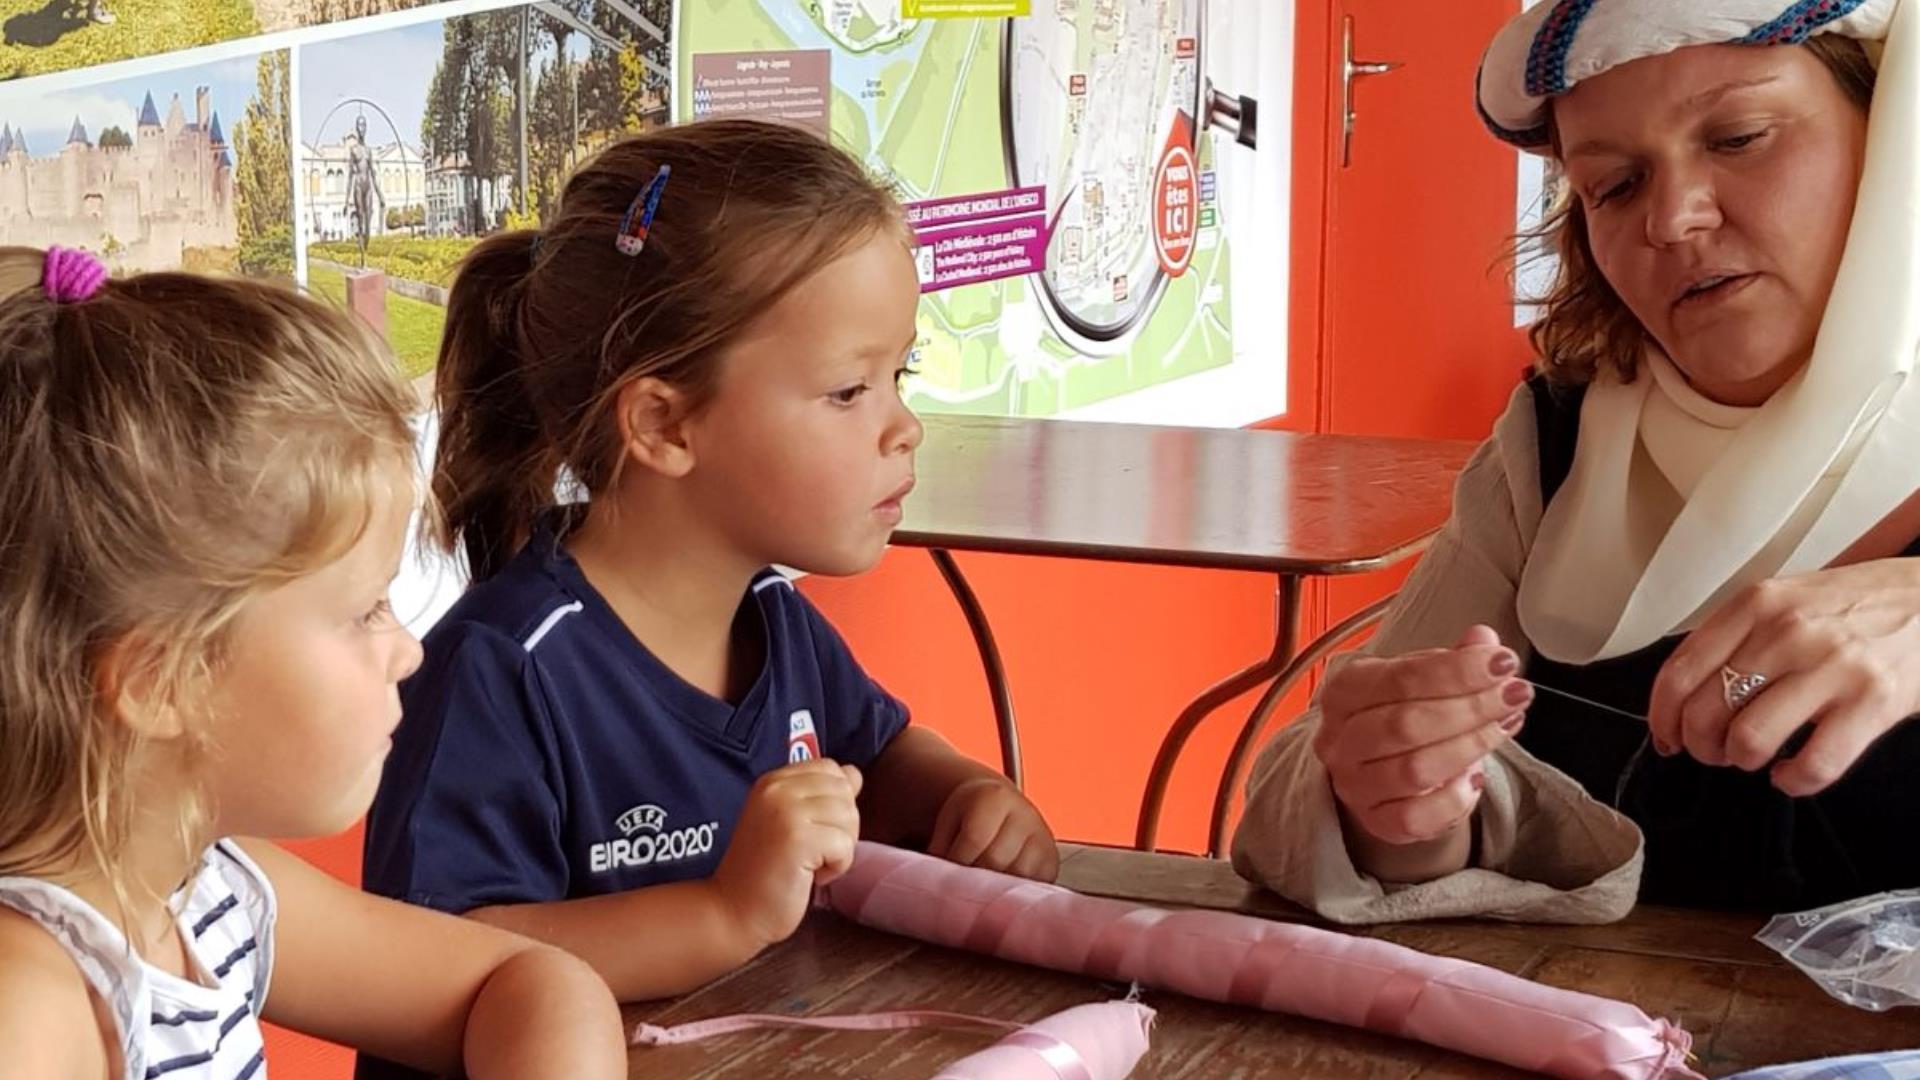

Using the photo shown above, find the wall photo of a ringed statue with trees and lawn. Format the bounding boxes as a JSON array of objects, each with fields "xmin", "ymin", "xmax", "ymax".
[{"xmin": 296, "ymin": 0, "xmax": 672, "ymax": 377}]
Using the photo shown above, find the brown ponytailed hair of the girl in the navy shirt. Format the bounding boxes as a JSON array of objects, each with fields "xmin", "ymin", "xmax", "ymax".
[{"xmin": 432, "ymin": 119, "xmax": 908, "ymax": 580}]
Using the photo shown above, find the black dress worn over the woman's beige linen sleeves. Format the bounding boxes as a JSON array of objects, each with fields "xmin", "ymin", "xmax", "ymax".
[{"xmin": 1519, "ymin": 377, "xmax": 1920, "ymax": 913}]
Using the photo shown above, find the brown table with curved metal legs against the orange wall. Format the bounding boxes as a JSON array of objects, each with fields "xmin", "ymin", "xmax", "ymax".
[{"xmin": 893, "ymin": 417, "xmax": 1473, "ymax": 853}]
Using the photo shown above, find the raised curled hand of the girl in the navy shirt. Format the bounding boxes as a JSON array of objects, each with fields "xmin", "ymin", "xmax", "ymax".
[{"xmin": 714, "ymin": 761, "xmax": 860, "ymax": 951}]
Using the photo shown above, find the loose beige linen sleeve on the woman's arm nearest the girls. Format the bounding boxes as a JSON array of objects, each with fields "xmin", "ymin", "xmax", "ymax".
[{"xmin": 1233, "ymin": 384, "xmax": 1642, "ymax": 924}]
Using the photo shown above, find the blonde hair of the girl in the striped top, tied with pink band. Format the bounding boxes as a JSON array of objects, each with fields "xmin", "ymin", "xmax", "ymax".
[{"xmin": 0, "ymin": 248, "xmax": 413, "ymax": 887}]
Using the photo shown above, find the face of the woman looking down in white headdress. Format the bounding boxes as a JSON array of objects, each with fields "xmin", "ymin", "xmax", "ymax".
[{"xmin": 1553, "ymin": 44, "xmax": 1866, "ymax": 405}]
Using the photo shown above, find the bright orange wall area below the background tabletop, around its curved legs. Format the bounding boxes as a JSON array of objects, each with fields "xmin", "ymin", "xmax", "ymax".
[{"xmin": 801, "ymin": 548, "xmax": 1273, "ymax": 849}]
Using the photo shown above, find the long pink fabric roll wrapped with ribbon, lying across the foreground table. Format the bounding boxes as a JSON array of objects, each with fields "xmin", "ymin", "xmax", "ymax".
[{"xmin": 816, "ymin": 844, "xmax": 1699, "ymax": 1080}]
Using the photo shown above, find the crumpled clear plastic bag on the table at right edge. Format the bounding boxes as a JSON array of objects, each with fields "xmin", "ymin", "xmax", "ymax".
[{"xmin": 1757, "ymin": 890, "xmax": 1920, "ymax": 1013}]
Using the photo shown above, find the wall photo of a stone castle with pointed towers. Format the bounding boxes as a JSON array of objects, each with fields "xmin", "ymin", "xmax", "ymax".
[{"xmin": 0, "ymin": 52, "xmax": 294, "ymax": 277}]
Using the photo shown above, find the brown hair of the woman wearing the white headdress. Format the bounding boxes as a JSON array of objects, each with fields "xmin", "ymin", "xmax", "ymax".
[{"xmin": 1515, "ymin": 35, "xmax": 1876, "ymax": 382}]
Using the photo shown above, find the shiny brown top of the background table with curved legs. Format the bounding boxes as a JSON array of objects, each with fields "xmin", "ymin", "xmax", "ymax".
[{"xmin": 893, "ymin": 417, "xmax": 1473, "ymax": 575}]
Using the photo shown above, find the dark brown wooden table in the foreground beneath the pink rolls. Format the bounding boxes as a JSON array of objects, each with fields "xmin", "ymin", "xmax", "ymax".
[{"xmin": 626, "ymin": 846, "xmax": 1920, "ymax": 1080}]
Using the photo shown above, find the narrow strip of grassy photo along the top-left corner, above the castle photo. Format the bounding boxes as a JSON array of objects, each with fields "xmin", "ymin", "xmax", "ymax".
[{"xmin": 0, "ymin": 0, "xmax": 428, "ymax": 79}]
